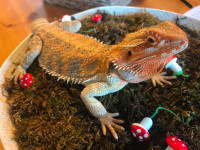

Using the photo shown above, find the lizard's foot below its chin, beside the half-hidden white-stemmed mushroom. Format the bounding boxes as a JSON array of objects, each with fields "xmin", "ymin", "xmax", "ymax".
[{"xmin": 151, "ymin": 72, "xmax": 176, "ymax": 87}]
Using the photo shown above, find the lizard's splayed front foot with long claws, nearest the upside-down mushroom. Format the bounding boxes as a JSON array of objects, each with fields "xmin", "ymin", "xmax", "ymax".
[{"xmin": 98, "ymin": 113, "xmax": 124, "ymax": 140}]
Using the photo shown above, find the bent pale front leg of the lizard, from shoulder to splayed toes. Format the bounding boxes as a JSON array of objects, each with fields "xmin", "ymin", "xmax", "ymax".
[{"xmin": 81, "ymin": 79, "xmax": 128, "ymax": 139}]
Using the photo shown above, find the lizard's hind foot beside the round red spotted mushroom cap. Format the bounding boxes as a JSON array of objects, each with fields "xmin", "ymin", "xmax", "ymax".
[{"xmin": 10, "ymin": 65, "xmax": 26, "ymax": 84}]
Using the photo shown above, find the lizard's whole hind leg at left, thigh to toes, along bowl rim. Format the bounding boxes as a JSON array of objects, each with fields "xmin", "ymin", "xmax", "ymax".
[{"xmin": 11, "ymin": 35, "xmax": 42, "ymax": 84}]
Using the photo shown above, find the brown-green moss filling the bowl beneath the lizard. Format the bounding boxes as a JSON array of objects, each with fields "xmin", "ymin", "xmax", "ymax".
[{"xmin": 3, "ymin": 12, "xmax": 200, "ymax": 150}]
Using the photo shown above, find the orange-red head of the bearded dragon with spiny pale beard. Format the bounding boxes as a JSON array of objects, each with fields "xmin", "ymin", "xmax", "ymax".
[{"xmin": 110, "ymin": 21, "xmax": 188, "ymax": 83}]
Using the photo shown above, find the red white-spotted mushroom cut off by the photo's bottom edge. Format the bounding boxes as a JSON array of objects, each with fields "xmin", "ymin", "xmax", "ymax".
[{"xmin": 165, "ymin": 136, "xmax": 188, "ymax": 150}]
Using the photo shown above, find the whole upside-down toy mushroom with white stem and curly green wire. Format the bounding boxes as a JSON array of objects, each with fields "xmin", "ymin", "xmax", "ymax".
[{"xmin": 131, "ymin": 117, "xmax": 153, "ymax": 141}]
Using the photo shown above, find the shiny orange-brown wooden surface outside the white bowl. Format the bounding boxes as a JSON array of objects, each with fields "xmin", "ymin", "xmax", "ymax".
[{"xmin": 0, "ymin": 0, "xmax": 200, "ymax": 150}]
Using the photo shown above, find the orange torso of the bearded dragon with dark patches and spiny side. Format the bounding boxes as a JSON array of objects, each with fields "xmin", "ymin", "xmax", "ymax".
[{"xmin": 32, "ymin": 19, "xmax": 111, "ymax": 83}]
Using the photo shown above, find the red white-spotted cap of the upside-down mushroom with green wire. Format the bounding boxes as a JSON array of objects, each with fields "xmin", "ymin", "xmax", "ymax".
[{"xmin": 131, "ymin": 123, "xmax": 150, "ymax": 141}]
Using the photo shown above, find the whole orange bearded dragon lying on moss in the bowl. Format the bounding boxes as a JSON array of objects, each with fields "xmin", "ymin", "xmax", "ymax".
[{"xmin": 13, "ymin": 19, "xmax": 188, "ymax": 139}]
